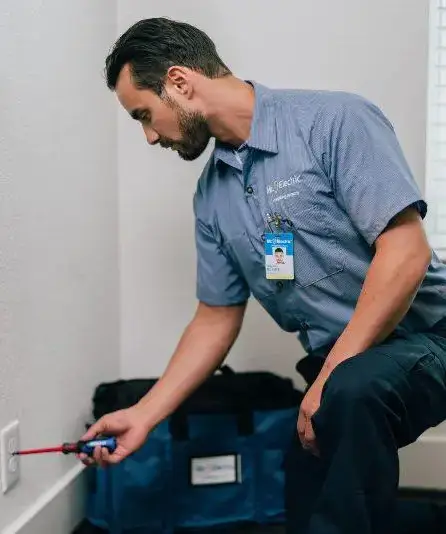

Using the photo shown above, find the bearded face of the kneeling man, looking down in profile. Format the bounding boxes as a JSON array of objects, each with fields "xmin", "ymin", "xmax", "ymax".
[{"xmin": 116, "ymin": 65, "xmax": 211, "ymax": 161}]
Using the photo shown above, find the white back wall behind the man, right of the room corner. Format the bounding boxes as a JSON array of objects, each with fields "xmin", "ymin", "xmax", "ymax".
[{"xmin": 118, "ymin": 0, "xmax": 428, "ymax": 390}]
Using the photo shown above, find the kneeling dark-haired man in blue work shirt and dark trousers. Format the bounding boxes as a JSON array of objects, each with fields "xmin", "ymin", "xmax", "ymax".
[{"xmin": 83, "ymin": 18, "xmax": 446, "ymax": 534}]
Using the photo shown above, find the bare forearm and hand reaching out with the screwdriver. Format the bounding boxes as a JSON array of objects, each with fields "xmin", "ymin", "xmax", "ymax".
[{"xmin": 79, "ymin": 302, "xmax": 246, "ymax": 466}]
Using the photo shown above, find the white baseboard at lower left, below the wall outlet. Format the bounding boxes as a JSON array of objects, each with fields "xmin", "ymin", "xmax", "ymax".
[{"xmin": 2, "ymin": 464, "xmax": 85, "ymax": 534}]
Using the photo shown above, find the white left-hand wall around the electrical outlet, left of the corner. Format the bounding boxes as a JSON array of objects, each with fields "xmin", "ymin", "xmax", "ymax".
[{"xmin": 0, "ymin": 0, "xmax": 119, "ymax": 533}]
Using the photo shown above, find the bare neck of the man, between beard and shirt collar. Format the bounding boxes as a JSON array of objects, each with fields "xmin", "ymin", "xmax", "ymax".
[{"xmin": 199, "ymin": 76, "xmax": 255, "ymax": 146}]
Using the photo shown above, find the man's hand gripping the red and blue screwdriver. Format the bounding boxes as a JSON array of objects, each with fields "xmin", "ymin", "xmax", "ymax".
[{"xmin": 79, "ymin": 406, "xmax": 151, "ymax": 467}]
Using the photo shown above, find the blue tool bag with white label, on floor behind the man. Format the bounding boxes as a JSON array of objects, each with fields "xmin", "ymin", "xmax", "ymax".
[{"xmin": 87, "ymin": 366, "xmax": 303, "ymax": 534}]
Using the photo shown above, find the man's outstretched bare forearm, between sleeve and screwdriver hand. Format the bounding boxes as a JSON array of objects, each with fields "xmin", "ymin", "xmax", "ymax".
[{"xmin": 137, "ymin": 305, "xmax": 245, "ymax": 428}]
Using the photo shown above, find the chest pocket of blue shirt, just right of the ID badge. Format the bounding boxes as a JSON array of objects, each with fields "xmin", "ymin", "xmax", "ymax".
[{"xmin": 290, "ymin": 206, "xmax": 344, "ymax": 287}]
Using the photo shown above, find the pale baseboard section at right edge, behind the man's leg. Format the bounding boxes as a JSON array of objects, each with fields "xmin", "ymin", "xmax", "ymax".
[{"xmin": 400, "ymin": 434, "xmax": 446, "ymax": 490}]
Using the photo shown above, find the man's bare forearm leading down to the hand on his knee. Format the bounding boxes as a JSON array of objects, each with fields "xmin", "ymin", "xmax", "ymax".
[{"xmin": 323, "ymin": 218, "xmax": 430, "ymax": 373}]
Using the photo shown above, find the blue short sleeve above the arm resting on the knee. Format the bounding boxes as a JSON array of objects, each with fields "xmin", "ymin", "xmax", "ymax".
[{"xmin": 328, "ymin": 97, "xmax": 427, "ymax": 245}]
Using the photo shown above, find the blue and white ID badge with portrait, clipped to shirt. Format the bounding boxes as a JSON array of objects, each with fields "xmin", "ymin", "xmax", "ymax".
[{"xmin": 265, "ymin": 233, "xmax": 294, "ymax": 280}]
